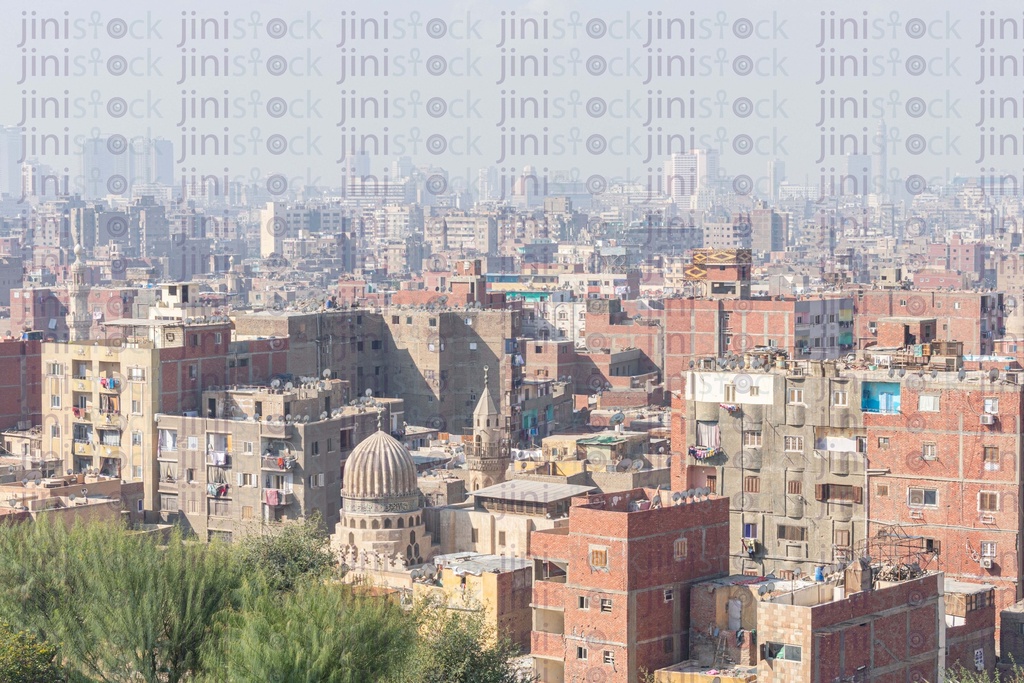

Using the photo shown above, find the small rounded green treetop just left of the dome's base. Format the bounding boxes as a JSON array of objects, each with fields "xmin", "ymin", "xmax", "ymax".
[{"xmin": 240, "ymin": 513, "xmax": 336, "ymax": 591}]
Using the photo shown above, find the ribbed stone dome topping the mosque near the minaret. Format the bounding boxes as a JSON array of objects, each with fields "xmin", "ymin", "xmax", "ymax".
[{"xmin": 342, "ymin": 430, "xmax": 419, "ymax": 501}]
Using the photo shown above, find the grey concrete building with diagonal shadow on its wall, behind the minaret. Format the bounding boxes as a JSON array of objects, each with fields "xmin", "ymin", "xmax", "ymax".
[{"xmin": 233, "ymin": 306, "xmax": 523, "ymax": 434}]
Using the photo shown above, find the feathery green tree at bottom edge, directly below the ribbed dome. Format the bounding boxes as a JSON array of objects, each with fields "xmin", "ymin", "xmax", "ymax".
[{"xmin": 209, "ymin": 580, "xmax": 416, "ymax": 683}]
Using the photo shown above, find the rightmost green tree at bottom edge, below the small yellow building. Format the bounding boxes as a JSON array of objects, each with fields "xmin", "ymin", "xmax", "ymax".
[{"xmin": 396, "ymin": 601, "xmax": 536, "ymax": 683}]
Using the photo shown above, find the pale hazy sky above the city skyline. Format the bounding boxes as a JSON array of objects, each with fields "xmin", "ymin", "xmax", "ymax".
[{"xmin": 6, "ymin": 1, "xmax": 1024, "ymax": 194}]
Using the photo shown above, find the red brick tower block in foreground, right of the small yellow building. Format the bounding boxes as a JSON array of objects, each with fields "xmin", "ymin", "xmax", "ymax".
[{"xmin": 529, "ymin": 488, "xmax": 729, "ymax": 683}]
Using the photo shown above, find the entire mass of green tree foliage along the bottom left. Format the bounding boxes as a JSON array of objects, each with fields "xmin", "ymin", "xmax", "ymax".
[{"xmin": 0, "ymin": 518, "xmax": 532, "ymax": 683}]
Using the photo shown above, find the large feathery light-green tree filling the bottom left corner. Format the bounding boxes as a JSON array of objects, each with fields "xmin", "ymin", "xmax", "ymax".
[{"xmin": 0, "ymin": 519, "xmax": 241, "ymax": 683}]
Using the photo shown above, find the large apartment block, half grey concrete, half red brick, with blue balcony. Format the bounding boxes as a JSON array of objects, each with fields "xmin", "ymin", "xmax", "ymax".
[{"xmin": 673, "ymin": 352, "xmax": 1022, "ymax": 608}]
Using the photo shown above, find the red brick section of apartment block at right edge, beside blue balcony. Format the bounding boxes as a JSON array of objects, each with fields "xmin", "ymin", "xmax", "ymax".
[{"xmin": 862, "ymin": 372, "xmax": 1024, "ymax": 626}]
